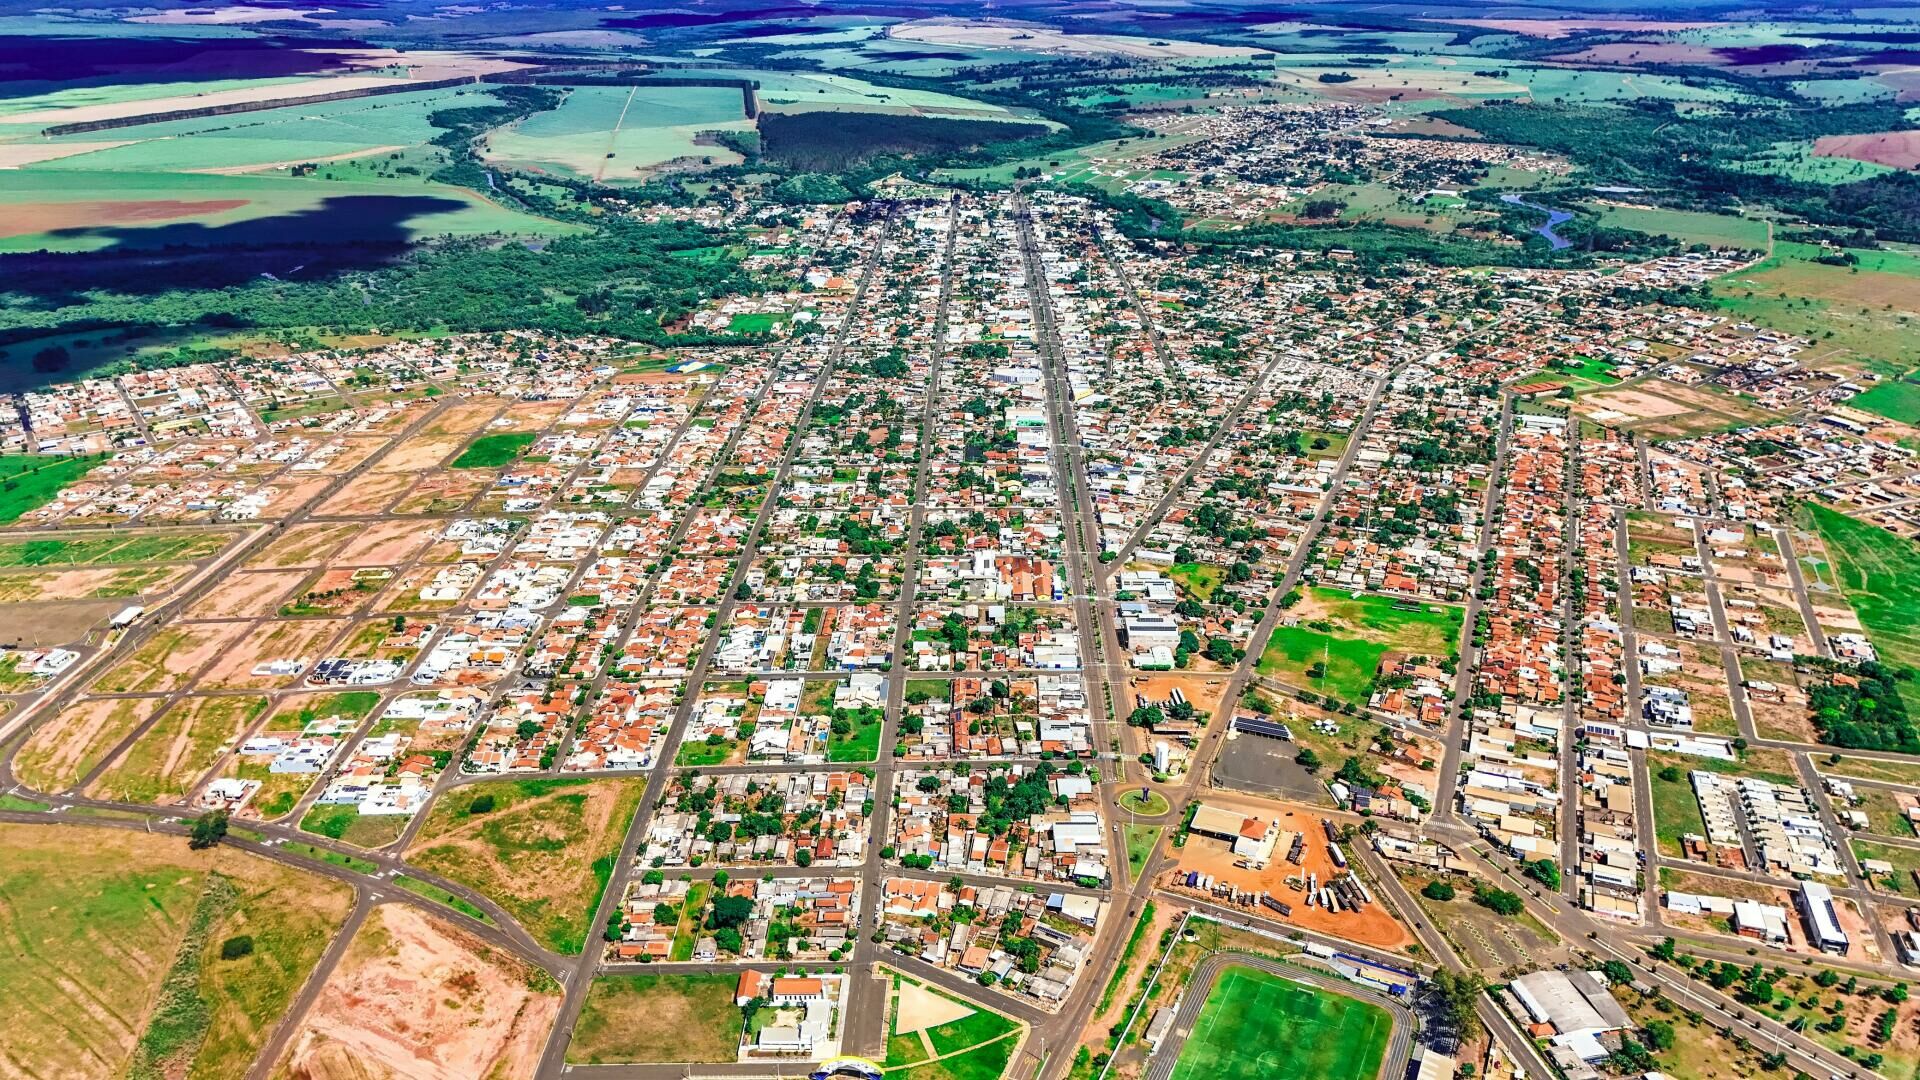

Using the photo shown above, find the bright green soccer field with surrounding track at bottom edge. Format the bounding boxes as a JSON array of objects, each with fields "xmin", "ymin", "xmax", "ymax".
[{"xmin": 1171, "ymin": 967, "xmax": 1394, "ymax": 1080}]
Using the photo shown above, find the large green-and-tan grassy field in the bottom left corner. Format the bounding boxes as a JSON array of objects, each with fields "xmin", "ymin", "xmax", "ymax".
[{"xmin": 0, "ymin": 824, "xmax": 351, "ymax": 1080}]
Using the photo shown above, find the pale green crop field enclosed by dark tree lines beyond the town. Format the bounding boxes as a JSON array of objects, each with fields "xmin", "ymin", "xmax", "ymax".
[{"xmin": 488, "ymin": 86, "xmax": 753, "ymax": 183}]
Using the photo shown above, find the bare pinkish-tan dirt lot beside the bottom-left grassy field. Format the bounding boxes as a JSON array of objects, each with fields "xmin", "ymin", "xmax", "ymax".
[{"xmin": 280, "ymin": 903, "xmax": 561, "ymax": 1080}]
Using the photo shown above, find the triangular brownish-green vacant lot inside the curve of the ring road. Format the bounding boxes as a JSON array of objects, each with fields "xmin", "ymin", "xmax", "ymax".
[{"xmin": 407, "ymin": 780, "xmax": 645, "ymax": 953}]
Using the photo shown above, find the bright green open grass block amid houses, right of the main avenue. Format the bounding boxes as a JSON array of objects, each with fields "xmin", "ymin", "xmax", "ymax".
[{"xmin": 1258, "ymin": 588, "xmax": 1463, "ymax": 705}]
